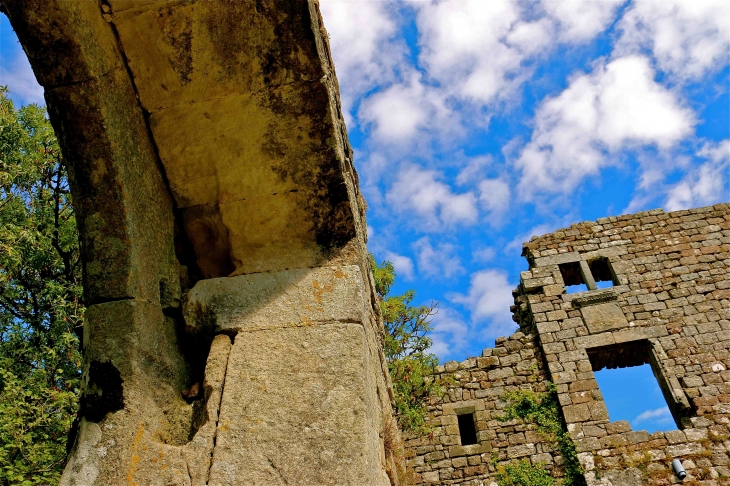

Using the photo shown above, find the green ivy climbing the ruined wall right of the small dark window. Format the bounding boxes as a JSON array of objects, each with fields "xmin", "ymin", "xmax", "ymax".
[{"xmin": 499, "ymin": 382, "xmax": 585, "ymax": 486}]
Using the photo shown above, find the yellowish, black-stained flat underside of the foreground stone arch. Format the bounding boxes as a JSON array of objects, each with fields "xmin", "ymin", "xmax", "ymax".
[{"xmin": 112, "ymin": 2, "xmax": 364, "ymax": 278}]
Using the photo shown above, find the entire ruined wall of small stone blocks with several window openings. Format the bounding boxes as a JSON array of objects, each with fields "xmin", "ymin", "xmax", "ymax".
[{"xmin": 406, "ymin": 204, "xmax": 730, "ymax": 486}]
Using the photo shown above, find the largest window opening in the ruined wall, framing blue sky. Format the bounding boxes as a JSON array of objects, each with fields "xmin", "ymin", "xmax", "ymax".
[{"xmin": 586, "ymin": 340, "xmax": 679, "ymax": 433}]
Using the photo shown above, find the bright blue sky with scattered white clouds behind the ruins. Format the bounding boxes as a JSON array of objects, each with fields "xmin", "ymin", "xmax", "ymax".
[{"xmin": 0, "ymin": 0, "xmax": 730, "ymax": 429}]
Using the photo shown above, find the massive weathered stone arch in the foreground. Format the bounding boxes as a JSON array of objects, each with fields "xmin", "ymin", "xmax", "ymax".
[{"xmin": 3, "ymin": 0, "xmax": 398, "ymax": 485}]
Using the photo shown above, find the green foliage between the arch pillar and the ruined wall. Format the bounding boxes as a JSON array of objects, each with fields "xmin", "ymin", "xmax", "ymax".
[{"xmin": 370, "ymin": 255, "xmax": 443, "ymax": 433}]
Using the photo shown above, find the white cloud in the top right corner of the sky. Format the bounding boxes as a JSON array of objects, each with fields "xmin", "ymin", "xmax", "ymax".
[{"xmin": 616, "ymin": 0, "xmax": 730, "ymax": 79}]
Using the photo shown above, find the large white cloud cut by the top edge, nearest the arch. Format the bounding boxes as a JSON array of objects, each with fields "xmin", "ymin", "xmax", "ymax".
[{"xmin": 417, "ymin": 0, "xmax": 620, "ymax": 104}]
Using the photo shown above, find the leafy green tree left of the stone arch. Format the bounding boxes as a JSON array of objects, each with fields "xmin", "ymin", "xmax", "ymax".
[{"xmin": 0, "ymin": 86, "xmax": 84, "ymax": 485}]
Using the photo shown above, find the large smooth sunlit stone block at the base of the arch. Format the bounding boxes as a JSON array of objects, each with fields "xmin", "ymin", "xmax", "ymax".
[{"xmin": 210, "ymin": 323, "xmax": 389, "ymax": 485}]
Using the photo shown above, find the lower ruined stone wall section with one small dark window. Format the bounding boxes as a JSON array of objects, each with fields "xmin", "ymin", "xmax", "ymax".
[{"xmin": 405, "ymin": 332, "xmax": 557, "ymax": 486}]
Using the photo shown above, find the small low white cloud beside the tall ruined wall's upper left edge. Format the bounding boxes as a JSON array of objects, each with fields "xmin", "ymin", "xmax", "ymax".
[{"xmin": 448, "ymin": 269, "xmax": 516, "ymax": 339}]
